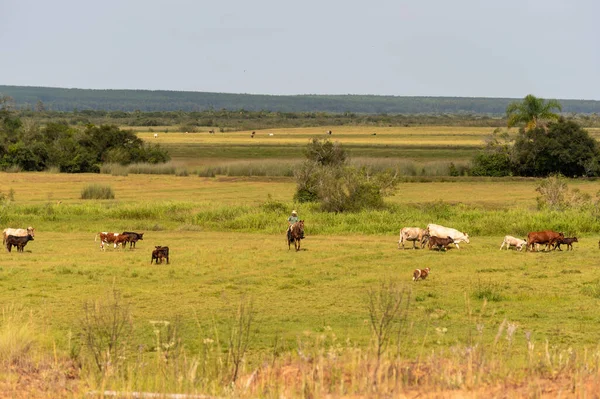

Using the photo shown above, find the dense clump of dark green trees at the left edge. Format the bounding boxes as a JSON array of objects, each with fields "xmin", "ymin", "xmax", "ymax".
[{"xmin": 0, "ymin": 98, "xmax": 169, "ymax": 173}]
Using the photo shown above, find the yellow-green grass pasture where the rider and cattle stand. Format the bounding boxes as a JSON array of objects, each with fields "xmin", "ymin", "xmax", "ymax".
[{"xmin": 0, "ymin": 123, "xmax": 600, "ymax": 396}]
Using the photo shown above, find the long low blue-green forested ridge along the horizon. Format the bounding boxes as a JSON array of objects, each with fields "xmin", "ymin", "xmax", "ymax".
[{"xmin": 0, "ymin": 85, "xmax": 600, "ymax": 115}]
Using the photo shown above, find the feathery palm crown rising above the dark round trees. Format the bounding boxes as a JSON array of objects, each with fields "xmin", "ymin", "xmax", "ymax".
[{"xmin": 506, "ymin": 94, "xmax": 562, "ymax": 130}]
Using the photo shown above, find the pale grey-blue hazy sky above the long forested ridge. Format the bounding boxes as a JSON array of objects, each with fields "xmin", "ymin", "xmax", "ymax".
[{"xmin": 0, "ymin": 0, "xmax": 600, "ymax": 100}]
